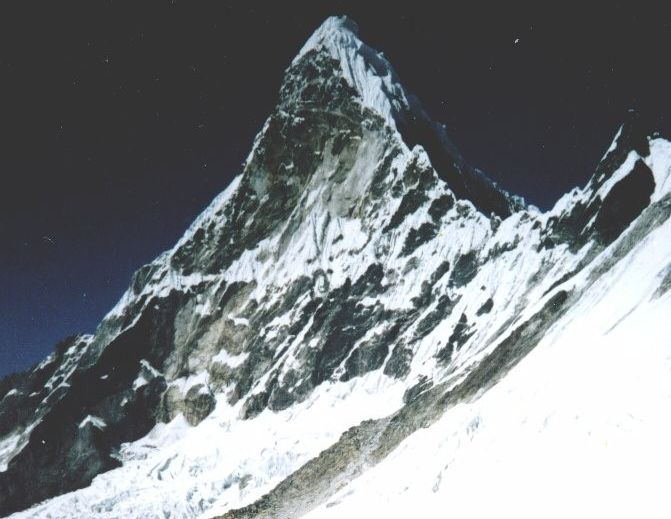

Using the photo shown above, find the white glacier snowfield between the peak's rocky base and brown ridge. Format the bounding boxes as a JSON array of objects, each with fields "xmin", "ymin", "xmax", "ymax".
[{"xmin": 10, "ymin": 374, "xmax": 403, "ymax": 518}]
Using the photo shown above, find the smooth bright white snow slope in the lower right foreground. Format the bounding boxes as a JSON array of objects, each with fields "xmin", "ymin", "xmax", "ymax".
[{"xmin": 305, "ymin": 200, "xmax": 671, "ymax": 519}]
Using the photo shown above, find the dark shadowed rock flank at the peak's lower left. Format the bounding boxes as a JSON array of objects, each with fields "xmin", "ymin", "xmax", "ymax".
[{"xmin": 0, "ymin": 295, "xmax": 179, "ymax": 512}]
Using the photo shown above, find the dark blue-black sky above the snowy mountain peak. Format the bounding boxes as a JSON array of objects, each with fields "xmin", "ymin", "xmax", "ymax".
[{"xmin": 0, "ymin": 0, "xmax": 671, "ymax": 376}]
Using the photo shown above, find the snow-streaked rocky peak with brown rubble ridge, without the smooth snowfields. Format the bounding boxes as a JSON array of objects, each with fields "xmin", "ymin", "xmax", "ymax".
[{"xmin": 0, "ymin": 14, "xmax": 669, "ymax": 517}]
